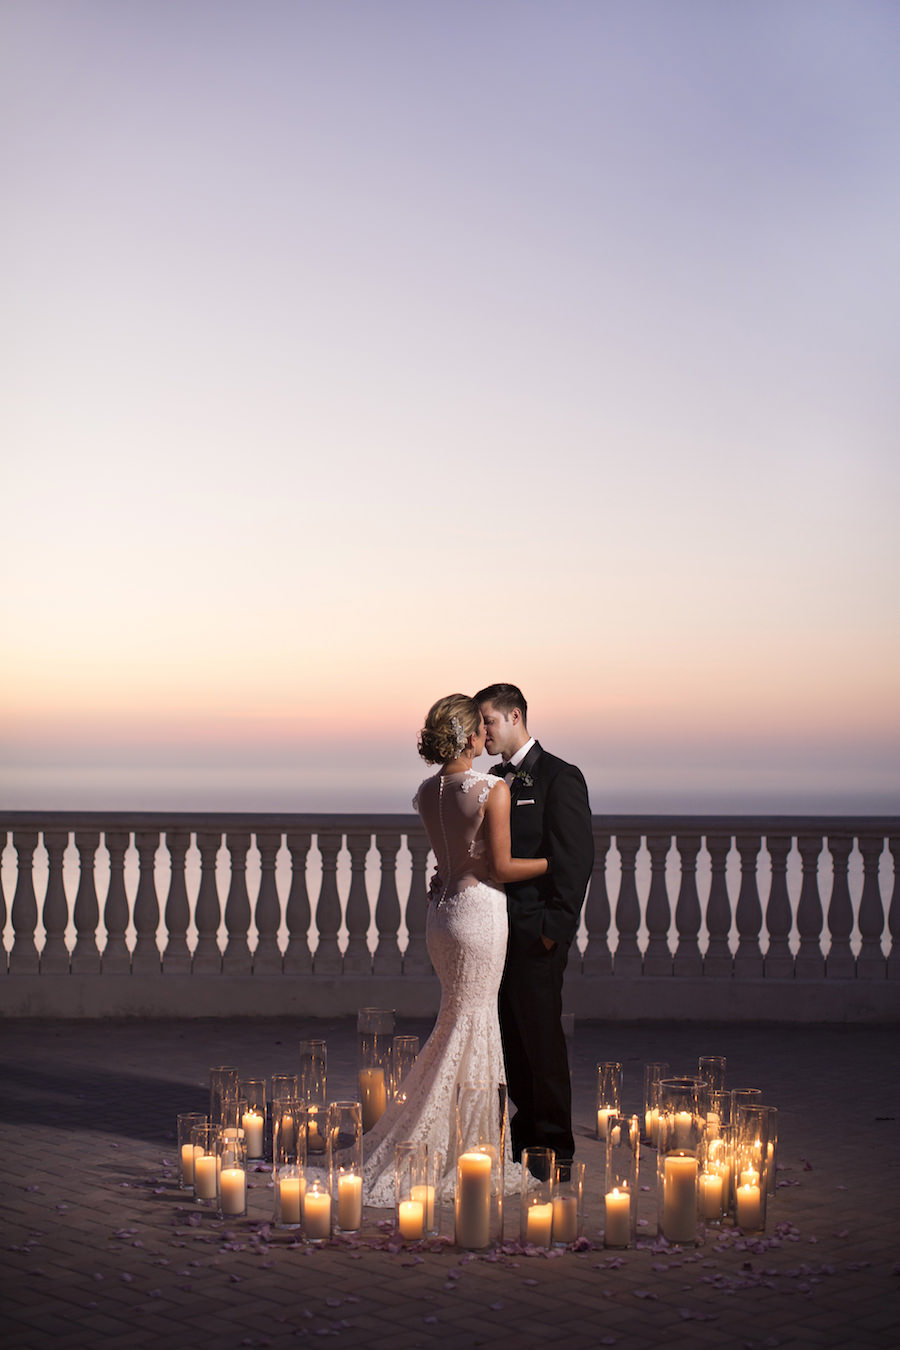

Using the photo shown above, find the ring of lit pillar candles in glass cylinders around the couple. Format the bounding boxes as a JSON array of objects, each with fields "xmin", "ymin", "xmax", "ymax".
[{"xmin": 178, "ymin": 1008, "xmax": 777, "ymax": 1250}]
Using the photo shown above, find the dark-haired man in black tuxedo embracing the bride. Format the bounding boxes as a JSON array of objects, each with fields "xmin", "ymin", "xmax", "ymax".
[{"xmin": 475, "ymin": 684, "xmax": 594, "ymax": 1162}]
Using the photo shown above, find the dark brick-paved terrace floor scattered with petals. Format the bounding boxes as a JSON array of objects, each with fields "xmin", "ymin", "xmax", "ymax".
[{"xmin": 0, "ymin": 1019, "xmax": 900, "ymax": 1350}]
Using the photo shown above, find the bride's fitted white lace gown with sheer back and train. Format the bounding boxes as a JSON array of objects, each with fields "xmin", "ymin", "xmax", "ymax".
[{"xmin": 364, "ymin": 770, "xmax": 507, "ymax": 1208}]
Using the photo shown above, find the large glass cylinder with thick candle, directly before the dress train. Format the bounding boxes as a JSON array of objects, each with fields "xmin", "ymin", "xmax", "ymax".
[{"xmin": 453, "ymin": 1083, "xmax": 506, "ymax": 1251}]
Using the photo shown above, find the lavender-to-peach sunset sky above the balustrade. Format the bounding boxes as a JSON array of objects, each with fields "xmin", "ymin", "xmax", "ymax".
[{"xmin": 0, "ymin": 0, "xmax": 900, "ymax": 813}]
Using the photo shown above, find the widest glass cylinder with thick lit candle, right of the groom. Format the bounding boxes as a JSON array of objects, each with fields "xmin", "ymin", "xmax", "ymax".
[{"xmin": 657, "ymin": 1077, "xmax": 707, "ymax": 1246}]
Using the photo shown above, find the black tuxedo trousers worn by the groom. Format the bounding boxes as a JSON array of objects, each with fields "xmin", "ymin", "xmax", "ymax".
[{"xmin": 499, "ymin": 921, "xmax": 575, "ymax": 1160}]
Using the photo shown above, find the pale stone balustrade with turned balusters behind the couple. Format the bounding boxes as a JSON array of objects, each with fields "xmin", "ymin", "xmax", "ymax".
[{"xmin": 0, "ymin": 811, "xmax": 900, "ymax": 1022}]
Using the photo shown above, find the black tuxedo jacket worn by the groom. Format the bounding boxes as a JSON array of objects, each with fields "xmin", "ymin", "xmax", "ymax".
[{"xmin": 496, "ymin": 741, "xmax": 594, "ymax": 946}]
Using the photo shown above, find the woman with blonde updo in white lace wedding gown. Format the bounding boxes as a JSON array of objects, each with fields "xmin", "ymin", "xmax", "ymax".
[{"xmin": 366, "ymin": 694, "xmax": 548, "ymax": 1208}]
